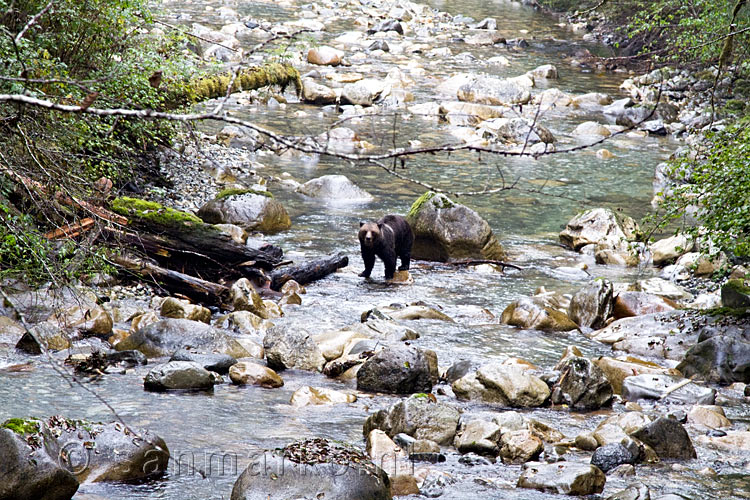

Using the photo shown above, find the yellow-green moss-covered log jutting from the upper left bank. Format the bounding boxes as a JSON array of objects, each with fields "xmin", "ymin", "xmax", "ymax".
[{"xmin": 168, "ymin": 63, "xmax": 302, "ymax": 106}]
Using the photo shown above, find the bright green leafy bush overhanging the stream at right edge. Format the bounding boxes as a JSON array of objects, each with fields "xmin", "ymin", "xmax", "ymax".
[{"xmin": 650, "ymin": 117, "xmax": 750, "ymax": 256}]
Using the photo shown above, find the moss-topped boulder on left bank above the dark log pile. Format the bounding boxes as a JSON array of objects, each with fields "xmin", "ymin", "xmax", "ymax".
[{"xmin": 198, "ymin": 190, "xmax": 292, "ymax": 233}]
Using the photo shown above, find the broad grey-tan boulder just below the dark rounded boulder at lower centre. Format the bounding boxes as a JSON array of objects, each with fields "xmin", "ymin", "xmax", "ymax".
[{"xmin": 364, "ymin": 396, "xmax": 460, "ymax": 445}]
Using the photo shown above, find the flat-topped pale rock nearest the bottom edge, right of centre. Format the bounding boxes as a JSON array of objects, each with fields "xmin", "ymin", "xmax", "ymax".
[{"xmin": 517, "ymin": 462, "xmax": 607, "ymax": 495}]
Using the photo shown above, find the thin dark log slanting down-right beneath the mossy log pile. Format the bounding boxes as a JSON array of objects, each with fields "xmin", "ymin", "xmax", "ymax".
[{"xmin": 111, "ymin": 255, "xmax": 229, "ymax": 308}]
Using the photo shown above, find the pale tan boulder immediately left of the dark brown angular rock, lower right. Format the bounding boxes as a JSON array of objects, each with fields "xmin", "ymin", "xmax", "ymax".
[{"xmin": 452, "ymin": 364, "xmax": 550, "ymax": 407}]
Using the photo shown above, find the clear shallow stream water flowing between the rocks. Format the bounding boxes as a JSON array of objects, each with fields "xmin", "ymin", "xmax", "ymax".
[{"xmin": 0, "ymin": 0, "xmax": 750, "ymax": 499}]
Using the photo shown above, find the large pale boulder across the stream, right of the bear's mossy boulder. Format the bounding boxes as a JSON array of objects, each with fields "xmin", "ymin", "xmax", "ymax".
[{"xmin": 560, "ymin": 208, "xmax": 634, "ymax": 250}]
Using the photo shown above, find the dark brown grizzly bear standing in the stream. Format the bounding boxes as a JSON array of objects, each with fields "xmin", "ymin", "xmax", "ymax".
[{"xmin": 359, "ymin": 215, "xmax": 414, "ymax": 280}]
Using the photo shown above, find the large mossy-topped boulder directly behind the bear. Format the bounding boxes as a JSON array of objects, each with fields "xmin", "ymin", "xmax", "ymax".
[{"xmin": 406, "ymin": 191, "xmax": 505, "ymax": 262}]
